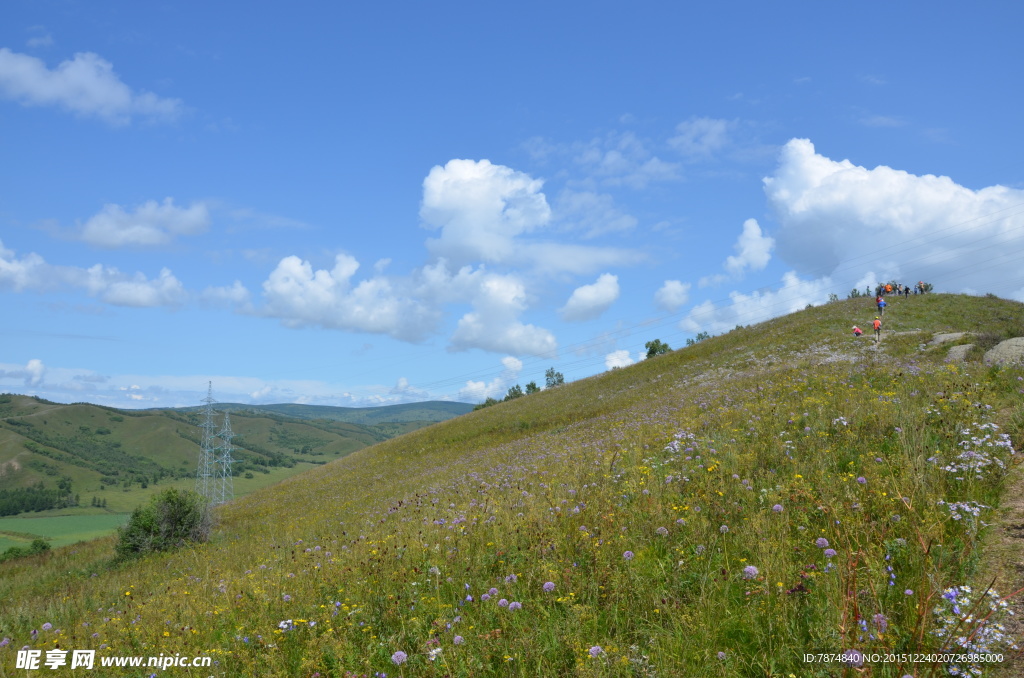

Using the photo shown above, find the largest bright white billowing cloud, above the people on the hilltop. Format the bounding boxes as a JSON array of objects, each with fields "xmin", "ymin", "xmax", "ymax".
[{"xmin": 764, "ymin": 139, "xmax": 1024, "ymax": 294}]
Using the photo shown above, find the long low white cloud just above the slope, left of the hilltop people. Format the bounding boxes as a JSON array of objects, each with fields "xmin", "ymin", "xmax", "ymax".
[{"xmin": 679, "ymin": 271, "xmax": 833, "ymax": 334}]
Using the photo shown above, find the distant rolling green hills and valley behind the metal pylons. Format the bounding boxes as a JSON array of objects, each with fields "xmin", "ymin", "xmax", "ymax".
[{"xmin": 0, "ymin": 394, "xmax": 460, "ymax": 552}]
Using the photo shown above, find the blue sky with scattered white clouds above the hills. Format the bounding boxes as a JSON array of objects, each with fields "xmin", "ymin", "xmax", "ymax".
[{"xmin": 0, "ymin": 0, "xmax": 1024, "ymax": 408}]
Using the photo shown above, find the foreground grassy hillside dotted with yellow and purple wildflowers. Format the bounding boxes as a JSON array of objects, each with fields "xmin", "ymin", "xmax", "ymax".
[{"xmin": 0, "ymin": 295, "xmax": 1024, "ymax": 676}]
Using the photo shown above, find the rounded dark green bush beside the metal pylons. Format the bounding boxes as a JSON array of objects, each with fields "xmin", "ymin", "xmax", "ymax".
[{"xmin": 115, "ymin": 488, "xmax": 212, "ymax": 558}]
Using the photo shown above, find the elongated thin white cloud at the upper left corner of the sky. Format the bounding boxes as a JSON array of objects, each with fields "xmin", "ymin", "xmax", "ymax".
[{"xmin": 0, "ymin": 47, "xmax": 184, "ymax": 125}]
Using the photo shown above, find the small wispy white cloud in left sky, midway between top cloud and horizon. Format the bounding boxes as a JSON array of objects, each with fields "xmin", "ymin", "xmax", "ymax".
[{"xmin": 80, "ymin": 198, "xmax": 210, "ymax": 248}]
